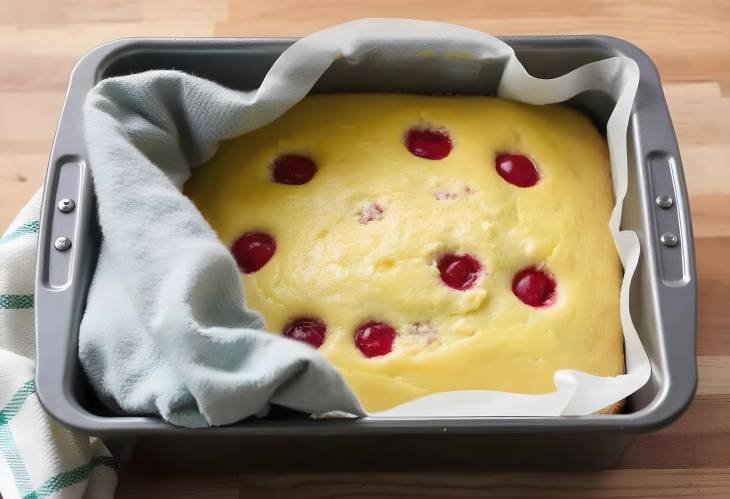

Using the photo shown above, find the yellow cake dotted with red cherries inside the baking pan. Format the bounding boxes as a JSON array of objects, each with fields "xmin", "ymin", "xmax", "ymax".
[{"xmin": 185, "ymin": 94, "xmax": 624, "ymax": 411}]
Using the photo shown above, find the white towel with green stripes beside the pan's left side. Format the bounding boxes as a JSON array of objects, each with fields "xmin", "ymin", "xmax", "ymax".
[{"xmin": 0, "ymin": 192, "xmax": 117, "ymax": 499}]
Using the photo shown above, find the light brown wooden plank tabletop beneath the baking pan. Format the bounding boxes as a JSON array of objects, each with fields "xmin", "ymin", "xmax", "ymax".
[{"xmin": 0, "ymin": 0, "xmax": 730, "ymax": 498}]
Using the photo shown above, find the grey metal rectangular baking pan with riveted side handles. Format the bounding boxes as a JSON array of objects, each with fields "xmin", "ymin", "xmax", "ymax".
[{"xmin": 36, "ymin": 36, "xmax": 697, "ymax": 469}]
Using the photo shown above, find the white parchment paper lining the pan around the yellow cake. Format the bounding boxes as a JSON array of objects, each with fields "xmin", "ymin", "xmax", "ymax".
[{"xmin": 280, "ymin": 19, "xmax": 651, "ymax": 417}]
